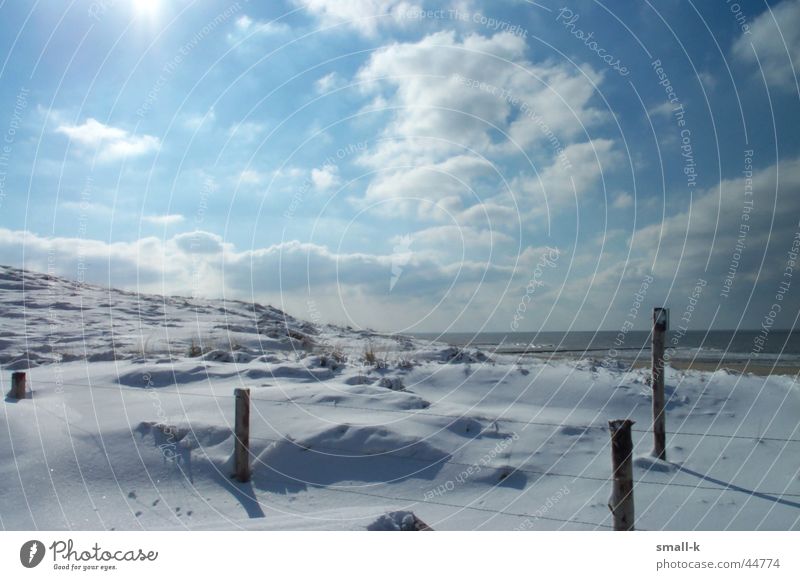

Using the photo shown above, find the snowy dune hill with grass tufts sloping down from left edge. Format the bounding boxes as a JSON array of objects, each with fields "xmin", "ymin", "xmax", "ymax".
[{"xmin": 0, "ymin": 266, "xmax": 412, "ymax": 369}]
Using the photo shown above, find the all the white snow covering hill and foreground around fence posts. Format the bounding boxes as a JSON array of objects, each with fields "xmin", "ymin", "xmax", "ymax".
[{"xmin": 0, "ymin": 267, "xmax": 800, "ymax": 530}]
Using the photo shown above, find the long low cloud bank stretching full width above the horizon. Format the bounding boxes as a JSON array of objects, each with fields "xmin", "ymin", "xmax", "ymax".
[{"xmin": 15, "ymin": 143, "xmax": 800, "ymax": 329}]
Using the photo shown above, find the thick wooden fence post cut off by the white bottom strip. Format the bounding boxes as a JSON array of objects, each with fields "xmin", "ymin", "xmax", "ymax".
[{"xmin": 608, "ymin": 419, "xmax": 634, "ymax": 531}]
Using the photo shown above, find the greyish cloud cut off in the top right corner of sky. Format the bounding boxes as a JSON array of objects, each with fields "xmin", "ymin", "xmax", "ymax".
[{"xmin": 733, "ymin": 0, "xmax": 800, "ymax": 91}]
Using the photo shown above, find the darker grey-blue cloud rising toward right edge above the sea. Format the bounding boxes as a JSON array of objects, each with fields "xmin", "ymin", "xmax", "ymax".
[{"xmin": 496, "ymin": 158, "xmax": 800, "ymax": 330}]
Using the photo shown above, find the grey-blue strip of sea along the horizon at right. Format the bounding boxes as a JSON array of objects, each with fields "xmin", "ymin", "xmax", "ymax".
[{"xmin": 410, "ymin": 330, "xmax": 800, "ymax": 365}]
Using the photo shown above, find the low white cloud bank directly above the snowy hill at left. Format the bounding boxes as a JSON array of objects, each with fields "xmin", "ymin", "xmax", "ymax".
[{"xmin": 0, "ymin": 228, "xmax": 513, "ymax": 327}]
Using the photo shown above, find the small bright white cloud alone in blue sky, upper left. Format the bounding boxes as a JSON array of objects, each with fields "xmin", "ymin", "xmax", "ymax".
[{"xmin": 56, "ymin": 118, "xmax": 161, "ymax": 161}]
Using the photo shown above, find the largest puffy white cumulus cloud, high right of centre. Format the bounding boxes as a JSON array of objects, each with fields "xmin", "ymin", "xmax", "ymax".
[{"xmin": 351, "ymin": 30, "xmax": 616, "ymax": 226}]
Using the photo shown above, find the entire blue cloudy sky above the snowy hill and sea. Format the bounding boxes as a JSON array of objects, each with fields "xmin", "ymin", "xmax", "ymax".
[{"xmin": 0, "ymin": 0, "xmax": 800, "ymax": 332}]
